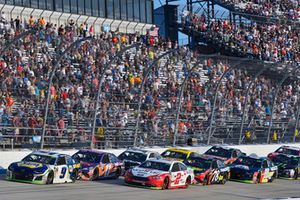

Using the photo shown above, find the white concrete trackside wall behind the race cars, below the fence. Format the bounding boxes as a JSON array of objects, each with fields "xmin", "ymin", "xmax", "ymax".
[{"xmin": 0, "ymin": 143, "xmax": 300, "ymax": 173}]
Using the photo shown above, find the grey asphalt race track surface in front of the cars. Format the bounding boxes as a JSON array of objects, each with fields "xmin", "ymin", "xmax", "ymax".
[{"xmin": 0, "ymin": 175, "xmax": 300, "ymax": 200}]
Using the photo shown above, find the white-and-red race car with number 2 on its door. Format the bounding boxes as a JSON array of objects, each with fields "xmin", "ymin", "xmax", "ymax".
[{"xmin": 125, "ymin": 159, "xmax": 194, "ymax": 189}]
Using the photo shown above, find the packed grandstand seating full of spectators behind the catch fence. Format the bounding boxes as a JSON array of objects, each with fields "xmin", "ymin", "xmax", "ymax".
[{"xmin": 0, "ymin": 0, "xmax": 300, "ymax": 148}]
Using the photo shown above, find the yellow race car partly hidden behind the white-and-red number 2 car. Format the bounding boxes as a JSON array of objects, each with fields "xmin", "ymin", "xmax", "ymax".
[{"xmin": 161, "ymin": 148, "xmax": 198, "ymax": 161}]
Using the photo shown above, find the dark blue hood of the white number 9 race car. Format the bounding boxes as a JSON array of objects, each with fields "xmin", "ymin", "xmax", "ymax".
[{"xmin": 9, "ymin": 161, "xmax": 49, "ymax": 174}]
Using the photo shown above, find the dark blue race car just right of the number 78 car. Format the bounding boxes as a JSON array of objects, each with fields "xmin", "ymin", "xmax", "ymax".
[{"xmin": 229, "ymin": 155, "xmax": 278, "ymax": 183}]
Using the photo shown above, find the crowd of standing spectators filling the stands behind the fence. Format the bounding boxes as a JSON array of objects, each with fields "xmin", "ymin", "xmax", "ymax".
[{"xmin": 0, "ymin": 9, "xmax": 300, "ymax": 147}]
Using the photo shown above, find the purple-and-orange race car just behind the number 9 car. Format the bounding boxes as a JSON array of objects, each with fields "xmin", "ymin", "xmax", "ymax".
[{"xmin": 72, "ymin": 149, "xmax": 124, "ymax": 181}]
